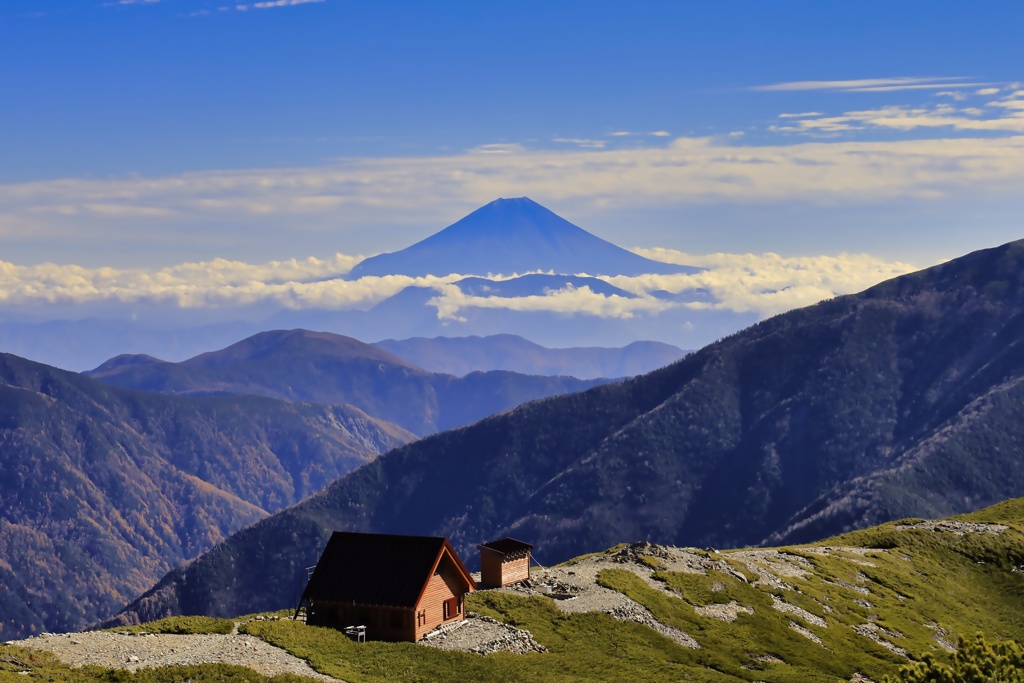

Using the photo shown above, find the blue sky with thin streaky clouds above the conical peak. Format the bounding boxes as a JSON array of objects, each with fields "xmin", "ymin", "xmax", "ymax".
[{"xmin": 0, "ymin": 0, "xmax": 1024, "ymax": 325}]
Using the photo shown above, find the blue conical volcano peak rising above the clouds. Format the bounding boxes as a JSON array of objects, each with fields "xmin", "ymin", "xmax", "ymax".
[{"xmin": 348, "ymin": 197, "xmax": 698, "ymax": 279}]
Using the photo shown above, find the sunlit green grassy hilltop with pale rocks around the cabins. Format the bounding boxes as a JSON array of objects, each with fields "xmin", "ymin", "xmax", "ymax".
[{"xmin": 0, "ymin": 499, "xmax": 1024, "ymax": 683}]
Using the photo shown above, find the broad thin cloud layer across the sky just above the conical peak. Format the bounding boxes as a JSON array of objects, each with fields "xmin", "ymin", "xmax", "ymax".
[{"xmin": 6, "ymin": 131, "xmax": 1024, "ymax": 262}]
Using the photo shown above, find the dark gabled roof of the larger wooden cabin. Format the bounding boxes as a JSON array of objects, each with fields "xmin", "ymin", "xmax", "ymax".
[{"xmin": 302, "ymin": 531, "xmax": 476, "ymax": 607}]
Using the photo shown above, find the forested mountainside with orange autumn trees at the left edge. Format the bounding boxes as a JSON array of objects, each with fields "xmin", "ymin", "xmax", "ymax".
[{"xmin": 0, "ymin": 354, "xmax": 415, "ymax": 638}]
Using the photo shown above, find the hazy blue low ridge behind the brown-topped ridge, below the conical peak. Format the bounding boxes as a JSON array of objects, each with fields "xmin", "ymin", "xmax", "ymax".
[{"xmin": 374, "ymin": 335, "xmax": 685, "ymax": 379}]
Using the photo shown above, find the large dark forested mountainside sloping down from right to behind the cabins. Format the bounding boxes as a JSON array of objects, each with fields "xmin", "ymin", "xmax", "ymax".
[{"xmin": 117, "ymin": 242, "xmax": 1024, "ymax": 618}]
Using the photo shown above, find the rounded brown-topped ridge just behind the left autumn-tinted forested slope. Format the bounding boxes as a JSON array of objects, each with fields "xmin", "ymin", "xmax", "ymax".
[{"xmin": 86, "ymin": 330, "xmax": 608, "ymax": 435}]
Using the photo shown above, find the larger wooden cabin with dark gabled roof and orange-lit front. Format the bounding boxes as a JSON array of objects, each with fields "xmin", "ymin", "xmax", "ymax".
[{"xmin": 302, "ymin": 531, "xmax": 476, "ymax": 642}]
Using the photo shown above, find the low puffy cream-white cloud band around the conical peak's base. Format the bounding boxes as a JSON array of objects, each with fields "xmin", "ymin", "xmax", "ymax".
[{"xmin": 0, "ymin": 249, "xmax": 915, "ymax": 321}]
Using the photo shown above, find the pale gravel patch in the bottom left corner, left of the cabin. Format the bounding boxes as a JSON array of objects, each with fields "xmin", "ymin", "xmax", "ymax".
[{"xmin": 11, "ymin": 631, "xmax": 337, "ymax": 681}]
